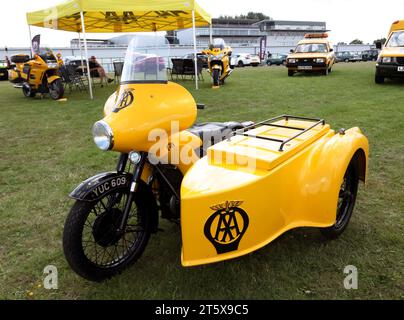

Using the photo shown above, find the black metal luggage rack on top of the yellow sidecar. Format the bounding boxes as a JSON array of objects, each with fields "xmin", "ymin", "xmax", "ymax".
[{"xmin": 229, "ymin": 114, "xmax": 325, "ymax": 152}]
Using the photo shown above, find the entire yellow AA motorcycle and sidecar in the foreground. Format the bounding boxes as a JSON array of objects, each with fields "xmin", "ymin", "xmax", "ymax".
[{"xmin": 63, "ymin": 36, "xmax": 369, "ymax": 281}]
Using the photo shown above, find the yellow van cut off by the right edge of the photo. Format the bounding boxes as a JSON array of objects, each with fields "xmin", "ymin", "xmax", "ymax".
[{"xmin": 375, "ymin": 20, "xmax": 404, "ymax": 84}]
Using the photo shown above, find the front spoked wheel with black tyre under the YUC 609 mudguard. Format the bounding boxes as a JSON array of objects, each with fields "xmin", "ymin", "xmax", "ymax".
[{"xmin": 63, "ymin": 189, "xmax": 150, "ymax": 281}]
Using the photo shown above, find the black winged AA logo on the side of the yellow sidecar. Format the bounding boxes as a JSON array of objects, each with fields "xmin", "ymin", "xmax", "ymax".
[{"xmin": 204, "ymin": 201, "xmax": 249, "ymax": 254}]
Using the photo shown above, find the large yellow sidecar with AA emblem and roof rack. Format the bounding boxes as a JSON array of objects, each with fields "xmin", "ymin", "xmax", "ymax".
[{"xmin": 181, "ymin": 115, "xmax": 369, "ymax": 266}]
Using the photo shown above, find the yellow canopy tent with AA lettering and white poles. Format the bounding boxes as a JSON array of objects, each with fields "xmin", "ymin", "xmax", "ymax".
[{"xmin": 27, "ymin": 0, "xmax": 212, "ymax": 98}]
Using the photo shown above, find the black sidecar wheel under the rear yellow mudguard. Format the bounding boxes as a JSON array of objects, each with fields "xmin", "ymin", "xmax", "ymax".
[{"xmin": 320, "ymin": 158, "xmax": 359, "ymax": 239}]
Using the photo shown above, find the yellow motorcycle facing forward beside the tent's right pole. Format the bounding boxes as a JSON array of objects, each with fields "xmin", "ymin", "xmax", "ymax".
[{"xmin": 202, "ymin": 38, "xmax": 233, "ymax": 88}]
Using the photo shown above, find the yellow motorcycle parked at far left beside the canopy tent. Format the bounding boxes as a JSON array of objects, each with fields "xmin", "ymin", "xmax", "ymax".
[{"xmin": 9, "ymin": 51, "xmax": 64, "ymax": 100}]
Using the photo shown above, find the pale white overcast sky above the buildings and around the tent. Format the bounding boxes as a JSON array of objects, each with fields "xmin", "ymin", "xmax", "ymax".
[{"xmin": 0, "ymin": 0, "xmax": 404, "ymax": 47}]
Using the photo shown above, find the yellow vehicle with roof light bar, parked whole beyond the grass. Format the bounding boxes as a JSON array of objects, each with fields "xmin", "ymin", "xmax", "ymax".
[{"xmin": 286, "ymin": 33, "xmax": 335, "ymax": 77}]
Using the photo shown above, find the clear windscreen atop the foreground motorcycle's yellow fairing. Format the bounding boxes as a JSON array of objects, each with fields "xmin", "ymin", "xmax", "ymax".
[{"xmin": 121, "ymin": 34, "xmax": 170, "ymax": 83}]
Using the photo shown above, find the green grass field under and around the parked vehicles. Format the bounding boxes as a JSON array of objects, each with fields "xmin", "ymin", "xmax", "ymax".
[{"xmin": 0, "ymin": 63, "xmax": 404, "ymax": 299}]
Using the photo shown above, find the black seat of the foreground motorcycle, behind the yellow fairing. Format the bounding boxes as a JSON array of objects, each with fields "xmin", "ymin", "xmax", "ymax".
[{"xmin": 188, "ymin": 121, "xmax": 254, "ymax": 157}]
